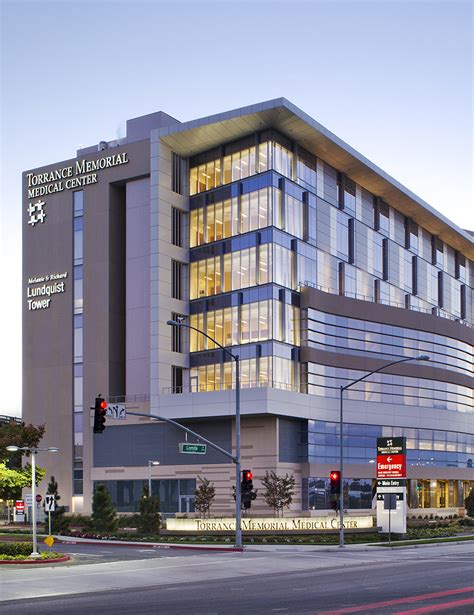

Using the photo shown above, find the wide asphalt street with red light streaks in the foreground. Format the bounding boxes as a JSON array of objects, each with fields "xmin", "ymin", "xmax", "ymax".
[{"xmin": 0, "ymin": 543, "xmax": 474, "ymax": 615}]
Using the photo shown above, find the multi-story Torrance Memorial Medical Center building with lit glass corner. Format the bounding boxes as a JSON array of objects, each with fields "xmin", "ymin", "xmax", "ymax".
[{"xmin": 23, "ymin": 99, "xmax": 474, "ymax": 515}]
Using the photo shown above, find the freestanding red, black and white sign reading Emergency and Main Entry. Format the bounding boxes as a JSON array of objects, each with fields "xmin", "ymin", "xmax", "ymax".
[{"xmin": 377, "ymin": 437, "xmax": 407, "ymax": 534}]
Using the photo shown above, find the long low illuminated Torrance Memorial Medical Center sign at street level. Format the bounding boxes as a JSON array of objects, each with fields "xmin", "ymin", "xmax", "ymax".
[{"xmin": 166, "ymin": 515, "xmax": 374, "ymax": 532}]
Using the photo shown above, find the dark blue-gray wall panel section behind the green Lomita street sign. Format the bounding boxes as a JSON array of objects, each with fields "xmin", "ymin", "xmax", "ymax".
[{"xmin": 94, "ymin": 419, "xmax": 232, "ymax": 467}]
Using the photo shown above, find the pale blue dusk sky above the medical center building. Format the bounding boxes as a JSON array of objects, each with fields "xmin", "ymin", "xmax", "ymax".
[{"xmin": 0, "ymin": 0, "xmax": 474, "ymax": 415}]
